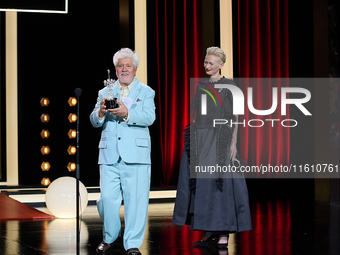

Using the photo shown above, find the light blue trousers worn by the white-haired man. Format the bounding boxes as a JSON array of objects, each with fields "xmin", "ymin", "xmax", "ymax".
[{"xmin": 97, "ymin": 158, "xmax": 151, "ymax": 250}]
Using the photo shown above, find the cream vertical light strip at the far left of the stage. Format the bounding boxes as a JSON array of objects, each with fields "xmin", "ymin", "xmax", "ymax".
[{"xmin": 6, "ymin": 12, "xmax": 18, "ymax": 185}]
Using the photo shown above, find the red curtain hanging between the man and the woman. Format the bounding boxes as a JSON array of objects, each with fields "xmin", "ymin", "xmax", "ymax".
[{"xmin": 153, "ymin": 0, "xmax": 203, "ymax": 186}]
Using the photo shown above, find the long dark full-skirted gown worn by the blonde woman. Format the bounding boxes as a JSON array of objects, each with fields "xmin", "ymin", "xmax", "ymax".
[{"xmin": 172, "ymin": 78, "xmax": 251, "ymax": 232}]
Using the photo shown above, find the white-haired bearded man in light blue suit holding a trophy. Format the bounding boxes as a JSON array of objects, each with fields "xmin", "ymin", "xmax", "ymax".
[{"xmin": 90, "ymin": 48, "xmax": 155, "ymax": 255}]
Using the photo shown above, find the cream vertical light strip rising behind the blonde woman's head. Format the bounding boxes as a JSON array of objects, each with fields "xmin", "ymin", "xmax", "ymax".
[{"xmin": 220, "ymin": 0, "xmax": 234, "ymax": 78}]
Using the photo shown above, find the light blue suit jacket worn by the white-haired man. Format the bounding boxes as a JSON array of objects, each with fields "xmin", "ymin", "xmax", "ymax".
[{"xmin": 90, "ymin": 78, "xmax": 155, "ymax": 164}]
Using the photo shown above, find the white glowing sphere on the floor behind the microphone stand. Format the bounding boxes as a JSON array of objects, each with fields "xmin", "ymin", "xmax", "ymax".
[{"xmin": 45, "ymin": 177, "xmax": 88, "ymax": 218}]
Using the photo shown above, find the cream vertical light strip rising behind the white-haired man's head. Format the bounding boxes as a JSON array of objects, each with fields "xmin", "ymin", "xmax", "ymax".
[{"xmin": 135, "ymin": 0, "xmax": 148, "ymax": 84}]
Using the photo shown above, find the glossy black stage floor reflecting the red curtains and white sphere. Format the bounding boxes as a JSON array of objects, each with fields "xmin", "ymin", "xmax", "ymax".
[{"xmin": 0, "ymin": 198, "xmax": 340, "ymax": 255}]
